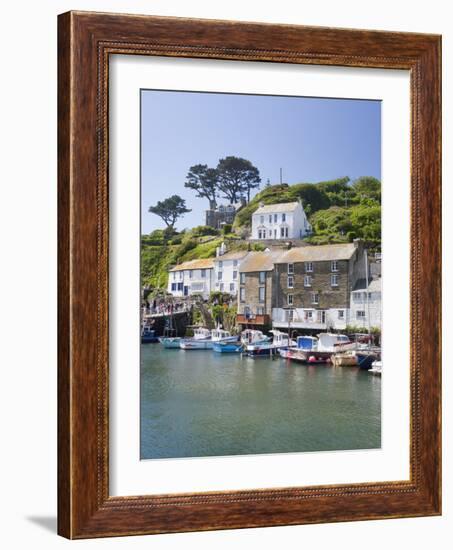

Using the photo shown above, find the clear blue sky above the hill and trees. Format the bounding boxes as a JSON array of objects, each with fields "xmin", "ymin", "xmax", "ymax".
[{"xmin": 141, "ymin": 90, "xmax": 381, "ymax": 233}]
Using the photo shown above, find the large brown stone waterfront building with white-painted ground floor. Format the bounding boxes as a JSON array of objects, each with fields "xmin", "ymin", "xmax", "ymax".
[{"xmin": 272, "ymin": 239, "xmax": 367, "ymax": 330}]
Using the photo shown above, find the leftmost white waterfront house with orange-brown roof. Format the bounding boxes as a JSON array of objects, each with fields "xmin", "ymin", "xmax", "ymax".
[{"xmin": 167, "ymin": 258, "xmax": 215, "ymax": 299}]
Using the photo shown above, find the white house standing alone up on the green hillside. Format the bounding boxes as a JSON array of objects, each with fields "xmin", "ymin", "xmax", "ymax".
[{"xmin": 252, "ymin": 202, "xmax": 311, "ymax": 240}]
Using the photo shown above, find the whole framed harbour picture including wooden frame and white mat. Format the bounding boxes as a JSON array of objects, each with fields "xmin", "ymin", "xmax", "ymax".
[{"xmin": 58, "ymin": 12, "xmax": 441, "ymax": 538}]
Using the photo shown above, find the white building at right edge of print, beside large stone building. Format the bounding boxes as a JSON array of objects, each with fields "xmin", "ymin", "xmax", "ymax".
[{"xmin": 349, "ymin": 277, "xmax": 382, "ymax": 328}]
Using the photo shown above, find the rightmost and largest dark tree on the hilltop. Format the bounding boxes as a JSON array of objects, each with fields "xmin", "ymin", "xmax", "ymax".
[{"xmin": 217, "ymin": 157, "xmax": 261, "ymax": 204}]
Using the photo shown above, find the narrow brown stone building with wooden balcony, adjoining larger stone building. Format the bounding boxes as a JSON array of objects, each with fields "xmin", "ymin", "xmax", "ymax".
[{"xmin": 237, "ymin": 251, "xmax": 282, "ymax": 327}]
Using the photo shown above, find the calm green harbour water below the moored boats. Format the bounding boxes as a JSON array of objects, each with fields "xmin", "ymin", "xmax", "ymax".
[{"xmin": 140, "ymin": 344, "xmax": 381, "ymax": 459}]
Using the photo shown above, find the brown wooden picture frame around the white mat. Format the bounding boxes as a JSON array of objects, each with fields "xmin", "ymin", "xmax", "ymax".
[{"xmin": 58, "ymin": 12, "xmax": 441, "ymax": 538}]
